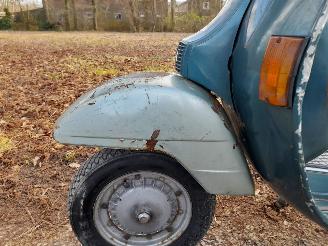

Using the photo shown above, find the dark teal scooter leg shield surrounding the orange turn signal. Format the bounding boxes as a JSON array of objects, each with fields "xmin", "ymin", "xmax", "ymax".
[{"xmin": 232, "ymin": 0, "xmax": 328, "ymax": 228}]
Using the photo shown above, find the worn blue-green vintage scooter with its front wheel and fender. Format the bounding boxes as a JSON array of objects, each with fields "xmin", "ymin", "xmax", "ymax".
[{"xmin": 54, "ymin": 0, "xmax": 328, "ymax": 246}]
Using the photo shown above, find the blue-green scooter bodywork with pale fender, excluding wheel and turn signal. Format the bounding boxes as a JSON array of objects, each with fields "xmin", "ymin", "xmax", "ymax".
[{"xmin": 54, "ymin": 0, "xmax": 328, "ymax": 232}]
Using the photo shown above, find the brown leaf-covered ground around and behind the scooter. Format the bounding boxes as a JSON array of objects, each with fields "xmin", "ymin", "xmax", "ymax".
[{"xmin": 0, "ymin": 32, "xmax": 328, "ymax": 245}]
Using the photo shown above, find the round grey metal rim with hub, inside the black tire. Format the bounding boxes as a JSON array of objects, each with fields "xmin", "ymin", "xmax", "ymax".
[{"xmin": 93, "ymin": 171, "xmax": 192, "ymax": 246}]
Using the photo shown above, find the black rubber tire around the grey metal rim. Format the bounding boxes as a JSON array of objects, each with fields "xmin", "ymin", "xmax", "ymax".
[{"xmin": 68, "ymin": 149, "xmax": 216, "ymax": 246}]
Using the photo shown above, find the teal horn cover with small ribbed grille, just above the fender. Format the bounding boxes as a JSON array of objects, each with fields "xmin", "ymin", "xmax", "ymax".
[{"xmin": 177, "ymin": 0, "xmax": 250, "ymax": 104}]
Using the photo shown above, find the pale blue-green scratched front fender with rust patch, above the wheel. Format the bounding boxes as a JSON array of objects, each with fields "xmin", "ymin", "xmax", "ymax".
[{"xmin": 54, "ymin": 73, "xmax": 254, "ymax": 195}]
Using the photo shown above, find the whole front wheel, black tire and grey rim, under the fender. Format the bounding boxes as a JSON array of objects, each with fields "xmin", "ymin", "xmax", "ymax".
[{"xmin": 68, "ymin": 149, "xmax": 215, "ymax": 246}]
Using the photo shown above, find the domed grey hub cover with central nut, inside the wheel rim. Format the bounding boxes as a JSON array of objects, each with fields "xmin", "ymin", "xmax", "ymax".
[{"xmin": 108, "ymin": 176, "xmax": 178, "ymax": 235}]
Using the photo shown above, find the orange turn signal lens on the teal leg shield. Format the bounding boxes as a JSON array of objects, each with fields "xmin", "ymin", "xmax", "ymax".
[{"xmin": 259, "ymin": 36, "xmax": 306, "ymax": 107}]
